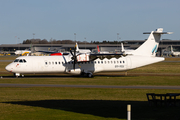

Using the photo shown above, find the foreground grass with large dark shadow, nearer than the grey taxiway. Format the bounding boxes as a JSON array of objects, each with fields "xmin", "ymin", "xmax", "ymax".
[{"xmin": 0, "ymin": 87, "xmax": 180, "ymax": 120}]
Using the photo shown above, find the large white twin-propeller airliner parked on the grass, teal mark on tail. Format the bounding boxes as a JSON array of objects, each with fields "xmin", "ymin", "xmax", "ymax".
[{"xmin": 5, "ymin": 28, "xmax": 171, "ymax": 77}]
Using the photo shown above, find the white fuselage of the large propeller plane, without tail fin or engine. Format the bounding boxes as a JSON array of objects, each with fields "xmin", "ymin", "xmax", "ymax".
[{"xmin": 6, "ymin": 55, "xmax": 164, "ymax": 74}]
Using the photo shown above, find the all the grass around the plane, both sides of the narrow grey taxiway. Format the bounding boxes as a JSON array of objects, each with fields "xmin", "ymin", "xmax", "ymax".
[{"xmin": 0, "ymin": 57, "xmax": 180, "ymax": 120}]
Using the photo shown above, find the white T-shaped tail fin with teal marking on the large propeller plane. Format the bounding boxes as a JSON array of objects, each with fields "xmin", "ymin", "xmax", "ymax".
[{"xmin": 132, "ymin": 28, "xmax": 172, "ymax": 56}]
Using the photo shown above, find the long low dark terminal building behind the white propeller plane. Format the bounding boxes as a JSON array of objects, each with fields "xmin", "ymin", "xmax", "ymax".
[{"xmin": 0, "ymin": 40, "xmax": 180, "ymax": 56}]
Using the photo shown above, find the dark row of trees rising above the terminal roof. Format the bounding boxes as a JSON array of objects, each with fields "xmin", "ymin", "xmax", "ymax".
[{"xmin": 22, "ymin": 39, "xmax": 121, "ymax": 44}]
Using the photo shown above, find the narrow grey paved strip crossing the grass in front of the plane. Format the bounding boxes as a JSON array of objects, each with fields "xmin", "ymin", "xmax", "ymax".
[{"xmin": 0, "ymin": 83, "xmax": 180, "ymax": 89}]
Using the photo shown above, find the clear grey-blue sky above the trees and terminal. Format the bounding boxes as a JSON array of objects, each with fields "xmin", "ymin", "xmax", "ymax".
[{"xmin": 0, "ymin": 0, "xmax": 180, "ymax": 44}]
